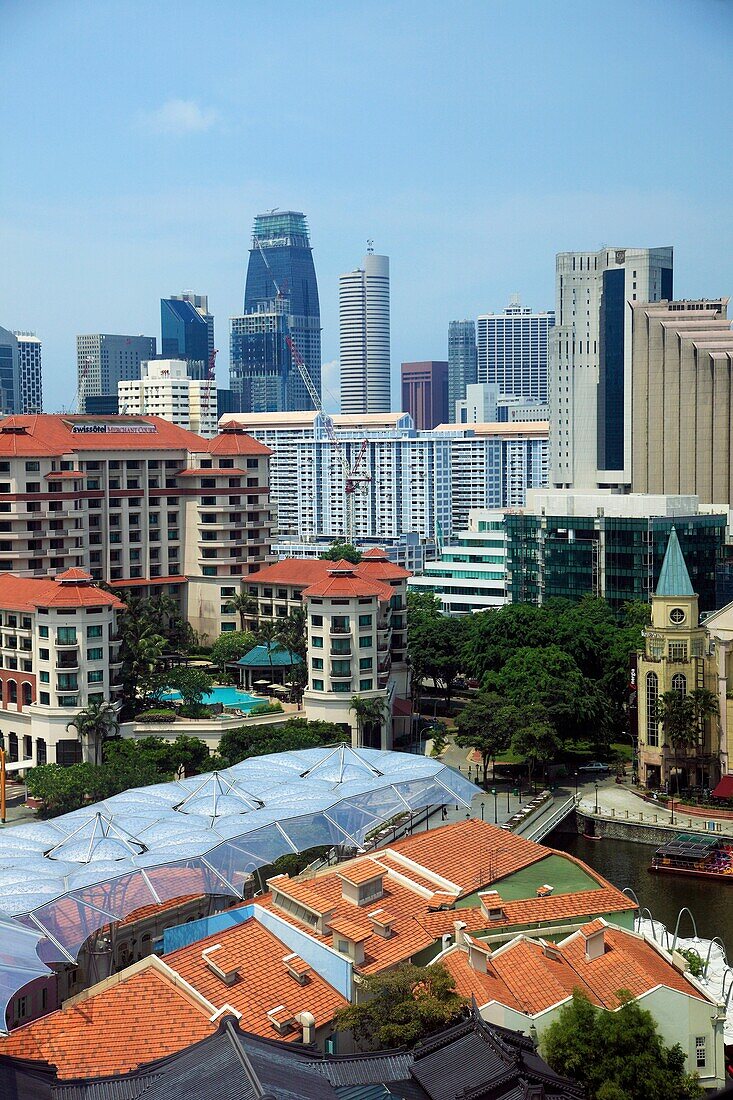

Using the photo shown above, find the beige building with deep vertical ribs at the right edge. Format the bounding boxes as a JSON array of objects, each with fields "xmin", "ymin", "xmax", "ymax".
[{"xmin": 631, "ymin": 298, "xmax": 733, "ymax": 507}]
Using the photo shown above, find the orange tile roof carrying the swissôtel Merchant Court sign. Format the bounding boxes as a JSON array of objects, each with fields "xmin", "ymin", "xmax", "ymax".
[{"xmin": 0, "ymin": 413, "xmax": 209, "ymax": 455}]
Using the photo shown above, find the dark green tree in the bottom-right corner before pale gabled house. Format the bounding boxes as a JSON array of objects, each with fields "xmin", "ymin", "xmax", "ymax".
[{"xmin": 541, "ymin": 990, "xmax": 703, "ymax": 1100}]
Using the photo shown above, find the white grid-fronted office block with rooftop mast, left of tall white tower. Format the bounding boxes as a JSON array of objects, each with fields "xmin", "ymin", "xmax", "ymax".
[{"xmin": 477, "ymin": 297, "xmax": 555, "ymax": 403}]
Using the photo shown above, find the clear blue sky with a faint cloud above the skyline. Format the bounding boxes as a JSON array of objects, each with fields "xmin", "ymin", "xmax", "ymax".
[{"xmin": 0, "ymin": 0, "xmax": 733, "ymax": 410}]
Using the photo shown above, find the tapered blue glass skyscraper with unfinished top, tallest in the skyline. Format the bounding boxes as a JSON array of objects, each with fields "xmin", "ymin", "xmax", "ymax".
[{"xmin": 230, "ymin": 210, "xmax": 320, "ymax": 413}]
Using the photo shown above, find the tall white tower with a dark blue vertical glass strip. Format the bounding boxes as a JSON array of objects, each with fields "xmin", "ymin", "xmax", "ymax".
[{"xmin": 548, "ymin": 248, "xmax": 672, "ymax": 492}]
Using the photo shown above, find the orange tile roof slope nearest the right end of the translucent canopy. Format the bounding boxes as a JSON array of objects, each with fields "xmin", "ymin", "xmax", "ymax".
[{"xmin": 390, "ymin": 817, "xmax": 551, "ymax": 894}]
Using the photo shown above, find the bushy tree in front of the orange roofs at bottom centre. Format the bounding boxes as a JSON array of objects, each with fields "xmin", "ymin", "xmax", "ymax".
[{"xmin": 333, "ymin": 963, "xmax": 467, "ymax": 1048}]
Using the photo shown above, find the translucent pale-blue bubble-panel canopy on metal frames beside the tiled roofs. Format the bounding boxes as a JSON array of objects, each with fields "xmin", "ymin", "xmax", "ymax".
[{"xmin": 0, "ymin": 745, "xmax": 478, "ymax": 1029}]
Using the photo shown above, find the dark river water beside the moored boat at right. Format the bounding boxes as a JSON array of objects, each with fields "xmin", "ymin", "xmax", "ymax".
[{"xmin": 543, "ymin": 833, "xmax": 733, "ymax": 958}]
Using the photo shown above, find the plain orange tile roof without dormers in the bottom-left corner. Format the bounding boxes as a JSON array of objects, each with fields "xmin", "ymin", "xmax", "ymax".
[{"xmin": 0, "ymin": 967, "xmax": 214, "ymax": 1078}]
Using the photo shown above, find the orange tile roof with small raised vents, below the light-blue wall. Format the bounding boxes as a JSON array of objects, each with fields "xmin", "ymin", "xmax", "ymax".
[{"xmin": 164, "ymin": 917, "xmax": 347, "ymax": 1041}]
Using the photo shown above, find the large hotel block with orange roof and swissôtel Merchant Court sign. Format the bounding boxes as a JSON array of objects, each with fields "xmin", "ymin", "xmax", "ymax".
[{"xmin": 0, "ymin": 415, "xmax": 272, "ymax": 638}]
